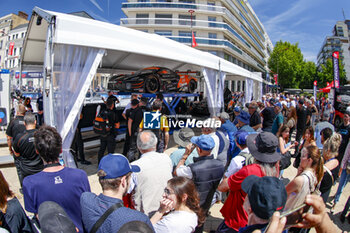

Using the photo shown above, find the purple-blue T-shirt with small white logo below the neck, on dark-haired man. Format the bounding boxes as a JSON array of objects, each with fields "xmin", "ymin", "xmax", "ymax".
[{"xmin": 23, "ymin": 167, "xmax": 90, "ymax": 232}]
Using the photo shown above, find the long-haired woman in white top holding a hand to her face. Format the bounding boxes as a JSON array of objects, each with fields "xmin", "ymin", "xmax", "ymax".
[{"xmin": 151, "ymin": 176, "xmax": 205, "ymax": 233}]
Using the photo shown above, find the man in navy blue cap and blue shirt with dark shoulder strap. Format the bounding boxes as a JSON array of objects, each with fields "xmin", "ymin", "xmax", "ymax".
[{"xmin": 80, "ymin": 154, "xmax": 153, "ymax": 232}]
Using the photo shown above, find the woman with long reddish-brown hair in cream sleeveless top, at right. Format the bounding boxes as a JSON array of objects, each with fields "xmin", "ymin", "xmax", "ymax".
[{"xmin": 284, "ymin": 145, "xmax": 323, "ymax": 232}]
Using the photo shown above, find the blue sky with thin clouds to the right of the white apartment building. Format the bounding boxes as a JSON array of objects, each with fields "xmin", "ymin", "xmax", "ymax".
[{"xmin": 249, "ymin": 0, "xmax": 350, "ymax": 62}]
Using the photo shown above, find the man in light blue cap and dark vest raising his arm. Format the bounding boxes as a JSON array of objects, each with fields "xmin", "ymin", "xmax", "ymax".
[{"xmin": 174, "ymin": 135, "xmax": 225, "ymax": 232}]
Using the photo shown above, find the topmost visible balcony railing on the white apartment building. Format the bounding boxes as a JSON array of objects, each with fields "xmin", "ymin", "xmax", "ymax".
[{"xmin": 122, "ymin": 2, "xmax": 225, "ymax": 13}]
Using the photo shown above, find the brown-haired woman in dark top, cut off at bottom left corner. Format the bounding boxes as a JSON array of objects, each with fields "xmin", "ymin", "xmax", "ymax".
[{"xmin": 0, "ymin": 171, "xmax": 33, "ymax": 233}]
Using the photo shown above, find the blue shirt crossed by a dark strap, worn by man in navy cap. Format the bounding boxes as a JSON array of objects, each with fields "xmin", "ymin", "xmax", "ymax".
[{"xmin": 80, "ymin": 192, "xmax": 153, "ymax": 232}]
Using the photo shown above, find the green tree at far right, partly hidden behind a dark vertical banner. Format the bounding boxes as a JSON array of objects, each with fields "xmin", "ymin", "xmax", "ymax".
[{"xmin": 317, "ymin": 58, "xmax": 347, "ymax": 88}]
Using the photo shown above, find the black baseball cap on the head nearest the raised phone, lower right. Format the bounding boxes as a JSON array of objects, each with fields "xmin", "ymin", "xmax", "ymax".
[{"xmin": 242, "ymin": 175, "xmax": 287, "ymax": 219}]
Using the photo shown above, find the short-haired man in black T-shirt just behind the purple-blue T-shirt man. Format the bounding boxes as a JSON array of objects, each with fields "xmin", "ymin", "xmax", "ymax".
[{"xmin": 13, "ymin": 112, "xmax": 44, "ymax": 186}]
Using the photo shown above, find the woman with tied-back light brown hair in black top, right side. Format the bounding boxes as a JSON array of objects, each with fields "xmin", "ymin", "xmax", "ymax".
[{"xmin": 320, "ymin": 133, "xmax": 341, "ymax": 203}]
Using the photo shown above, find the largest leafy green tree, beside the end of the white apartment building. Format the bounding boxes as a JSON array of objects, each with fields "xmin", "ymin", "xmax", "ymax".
[{"xmin": 268, "ymin": 41, "xmax": 304, "ymax": 89}]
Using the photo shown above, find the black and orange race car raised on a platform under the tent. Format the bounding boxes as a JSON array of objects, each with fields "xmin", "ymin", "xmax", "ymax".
[{"xmin": 107, "ymin": 66, "xmax": 197, "ymax": 93}]
